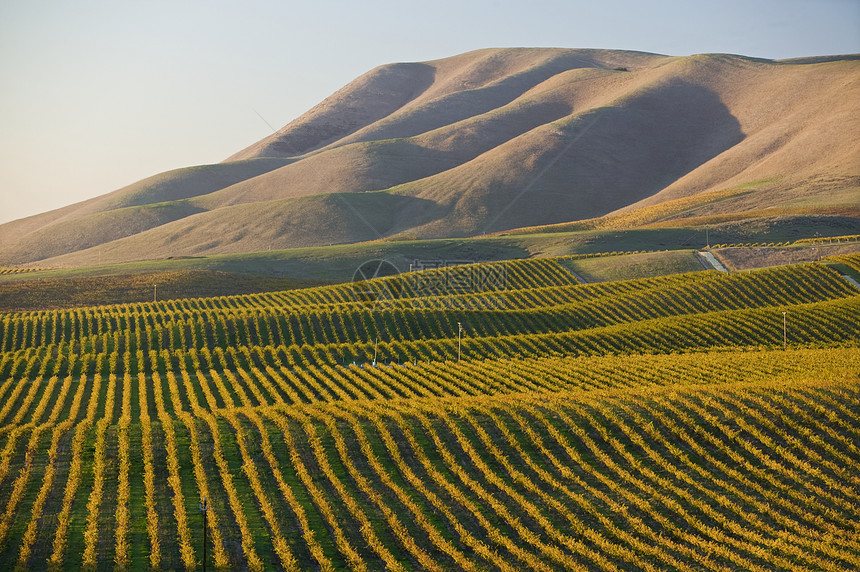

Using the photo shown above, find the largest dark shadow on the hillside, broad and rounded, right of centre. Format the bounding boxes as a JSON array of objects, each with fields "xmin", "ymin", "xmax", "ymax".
[{"xmin": 476, "ymin": 80, "xmax": 744, "ymax": 232}]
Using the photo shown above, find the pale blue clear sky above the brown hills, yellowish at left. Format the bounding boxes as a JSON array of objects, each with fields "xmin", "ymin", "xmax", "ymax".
[{"xmin": 0, "ymin": 0, "xmax": 860, "ymax": 223}]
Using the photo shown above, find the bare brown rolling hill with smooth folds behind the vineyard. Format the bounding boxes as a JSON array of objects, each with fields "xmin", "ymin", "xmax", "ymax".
[{"xmin": 0, "ymin": 48, "xmax": 860, "ymax": 266}]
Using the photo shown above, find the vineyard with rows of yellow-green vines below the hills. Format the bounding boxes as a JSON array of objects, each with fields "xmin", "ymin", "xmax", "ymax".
[{"xmin": 0, "ymin": 256, "xmax": 860, "ymax": 570}]
